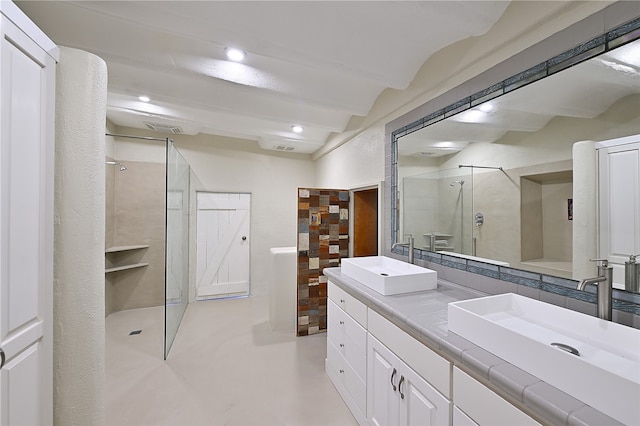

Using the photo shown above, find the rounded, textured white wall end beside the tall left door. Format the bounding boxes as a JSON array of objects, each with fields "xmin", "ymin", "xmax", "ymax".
[{"xmin": 53, "ymin": 48, "xmax": 107, "ymax": 425}]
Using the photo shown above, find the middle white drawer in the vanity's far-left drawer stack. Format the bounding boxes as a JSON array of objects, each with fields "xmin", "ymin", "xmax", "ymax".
[{"xmin": 327, "ymin": 301, "xmax": 367, "ymax": 380}]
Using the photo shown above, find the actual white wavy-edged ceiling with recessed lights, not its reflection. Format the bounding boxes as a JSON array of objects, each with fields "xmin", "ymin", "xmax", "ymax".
[{"xmin": 16, "ymin": 1, "xmax": 508, "ymax": 153}]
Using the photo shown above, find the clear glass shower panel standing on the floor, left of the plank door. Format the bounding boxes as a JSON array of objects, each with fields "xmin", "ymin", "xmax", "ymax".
[{"xmin": 164, "ymin": 140, "xmax": 191, "ymax": 359}]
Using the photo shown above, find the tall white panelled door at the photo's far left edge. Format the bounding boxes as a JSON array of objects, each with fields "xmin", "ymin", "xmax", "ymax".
[{"xmin": 0, "ymin": 7, "xmax": 55, "ymax": 425}]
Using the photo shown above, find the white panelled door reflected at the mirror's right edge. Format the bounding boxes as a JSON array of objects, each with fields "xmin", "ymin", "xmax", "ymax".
[{"xmin": 598, "ymin": 136, "xmax": 640, "ymax": 288}]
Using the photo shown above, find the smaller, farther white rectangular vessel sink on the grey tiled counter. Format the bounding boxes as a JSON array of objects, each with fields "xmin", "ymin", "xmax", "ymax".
[{"xmin": 341, "ymin": 256, "xmax": 438, "ymax": 296}]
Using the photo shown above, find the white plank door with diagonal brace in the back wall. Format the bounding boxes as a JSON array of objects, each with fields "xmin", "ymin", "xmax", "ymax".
[{"xmin": 196, "ymin": 192, "xmax": 251, "ymax": 300}]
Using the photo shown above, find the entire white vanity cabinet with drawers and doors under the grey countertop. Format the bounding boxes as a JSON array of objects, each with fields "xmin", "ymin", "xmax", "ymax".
[{"xmin": 326, "ymin": 281, "xmax": 539, "ymax": 426}]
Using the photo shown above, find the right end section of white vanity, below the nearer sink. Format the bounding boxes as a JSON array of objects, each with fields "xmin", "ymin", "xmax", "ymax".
[{"xmin": 453, "ymin": 367, "xmax": 540, "ymax": 426}]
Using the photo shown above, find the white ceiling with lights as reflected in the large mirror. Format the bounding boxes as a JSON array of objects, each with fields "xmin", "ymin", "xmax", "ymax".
[{"xmin": 398, "ymin": 41, "xmax": 640, "ymax": 157}]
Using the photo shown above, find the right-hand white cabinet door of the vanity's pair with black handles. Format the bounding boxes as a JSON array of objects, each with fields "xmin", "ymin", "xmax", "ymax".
[{"xmin": 398, "ymin": 364, "xmax": 450, "ymax": 426}]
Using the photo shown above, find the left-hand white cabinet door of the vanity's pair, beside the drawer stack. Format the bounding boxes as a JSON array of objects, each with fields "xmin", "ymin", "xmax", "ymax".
[{"xmin": 367, "ymin": 335, "xmax": 400, "ymax": 426}]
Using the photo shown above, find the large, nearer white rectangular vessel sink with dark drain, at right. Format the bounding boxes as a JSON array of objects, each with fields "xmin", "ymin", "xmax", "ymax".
[{"xmin": 448, "ymin": 293, "xmax": 640, "ymax": 425}]
